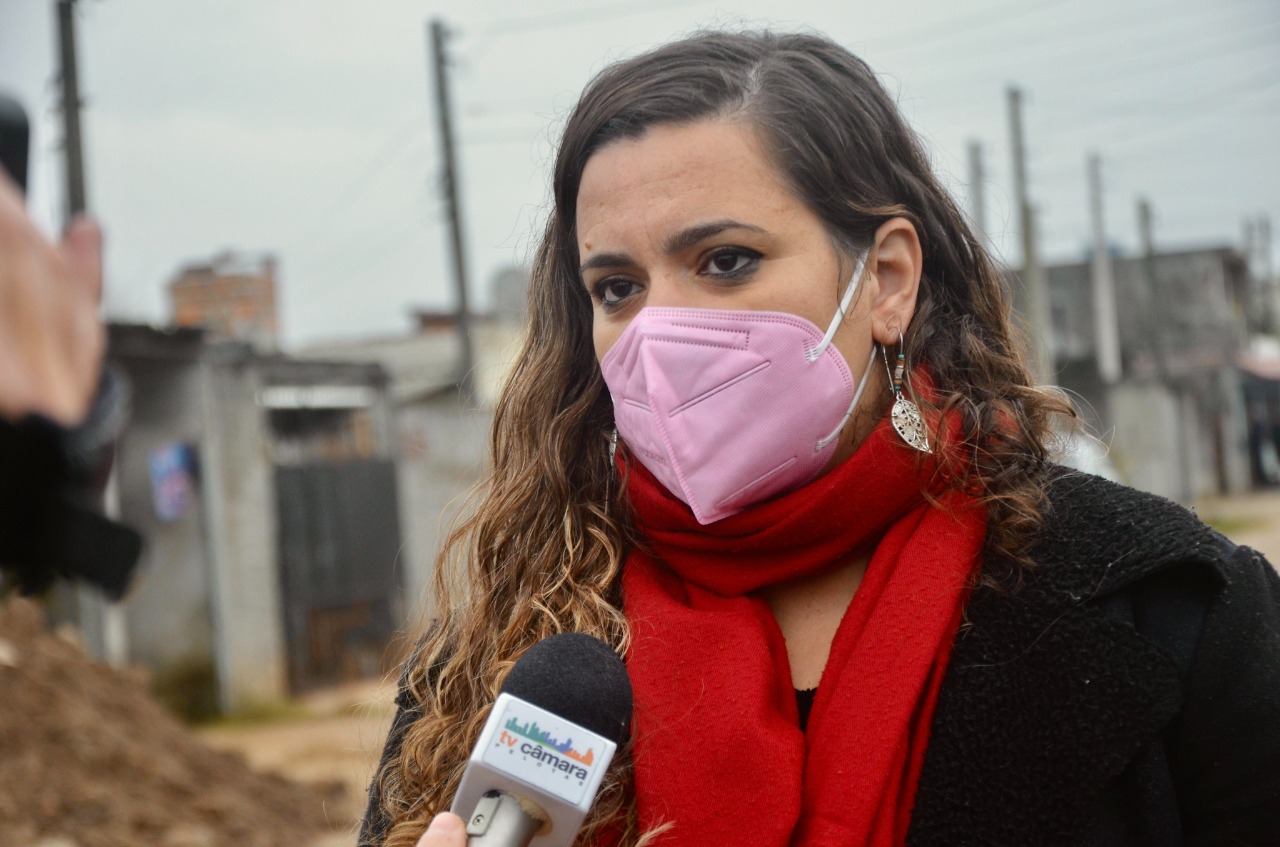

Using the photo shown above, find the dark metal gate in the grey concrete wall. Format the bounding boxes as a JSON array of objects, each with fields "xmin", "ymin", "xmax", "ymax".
[{"xmin": 275, "ymin": 459, "xmax": 401, "ymax": 691}]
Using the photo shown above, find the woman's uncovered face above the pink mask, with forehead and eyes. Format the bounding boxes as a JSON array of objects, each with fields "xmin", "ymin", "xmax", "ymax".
[{"xmin": 577, "ymin": 120, "xmax": 919, "ymax": 461}]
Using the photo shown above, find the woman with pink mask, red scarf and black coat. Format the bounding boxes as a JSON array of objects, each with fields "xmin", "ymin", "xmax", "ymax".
[{"xmin": 362, "ymin": 33, "xmax": 1280, "ymax": 846}]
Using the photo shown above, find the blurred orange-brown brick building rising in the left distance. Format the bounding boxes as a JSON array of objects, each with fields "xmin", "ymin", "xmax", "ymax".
[{"xmin": 169, "ymin": 251, "xmax": 279, "ymax": 349}]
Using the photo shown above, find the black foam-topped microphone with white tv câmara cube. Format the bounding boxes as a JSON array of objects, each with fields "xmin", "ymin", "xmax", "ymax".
[{"xmin": 451, "ymin": 632, "xmax": 631, "ymax": 847}]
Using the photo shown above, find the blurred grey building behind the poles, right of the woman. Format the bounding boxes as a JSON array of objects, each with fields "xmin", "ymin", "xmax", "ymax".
[{"xmin": 1024, "ymin": 247, "xmax": 1256, "ymax": 502}]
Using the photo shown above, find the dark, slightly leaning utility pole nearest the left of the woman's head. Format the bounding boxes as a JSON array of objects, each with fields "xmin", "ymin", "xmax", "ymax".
[{"xmin": 428, "ymin": 18, "xmax": 476, "ymax": 406}]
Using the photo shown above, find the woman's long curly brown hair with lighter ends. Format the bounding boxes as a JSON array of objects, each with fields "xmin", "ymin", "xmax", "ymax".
[{"xmin": 378, "ymin": 32, "xmax": 1074, "ymax": 847}]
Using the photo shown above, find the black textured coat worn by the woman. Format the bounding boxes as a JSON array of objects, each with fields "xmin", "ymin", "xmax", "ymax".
[{"xmin": 360, "ymin": 472, "xmax": 1280, "ymax": 847}]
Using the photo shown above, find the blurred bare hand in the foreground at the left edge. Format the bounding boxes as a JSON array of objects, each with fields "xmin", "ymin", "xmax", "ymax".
[{"xmin": 0, "ymin": 170, "xmax": 106, "ymax": 426}]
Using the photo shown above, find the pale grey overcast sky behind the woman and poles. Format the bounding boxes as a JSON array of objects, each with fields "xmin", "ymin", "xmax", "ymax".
[{"xmin": 0, "ymin": 0, "xmax": 1280, "ymax": 344}]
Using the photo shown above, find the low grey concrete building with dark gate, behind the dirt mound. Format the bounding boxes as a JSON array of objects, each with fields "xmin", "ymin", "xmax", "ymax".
[{"xmin": 92, "ymin": 324, "xmax": 404, "ymax": 714}]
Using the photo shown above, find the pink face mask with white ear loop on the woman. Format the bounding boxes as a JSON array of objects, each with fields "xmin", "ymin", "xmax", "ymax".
[{"xmin": 600, "ymin": 257, "xmax": 876, "ymax": 525}]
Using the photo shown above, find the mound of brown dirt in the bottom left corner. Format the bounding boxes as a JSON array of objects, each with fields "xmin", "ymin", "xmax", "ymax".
[{"xmin": 0, "ymin": 600, "xmax": 349, "ymax": 847}]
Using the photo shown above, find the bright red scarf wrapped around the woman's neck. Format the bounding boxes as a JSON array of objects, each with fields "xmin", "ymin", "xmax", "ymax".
[{"xmin": 622, "ymin": 421, "xmax": 986, "ymax": 847}]
